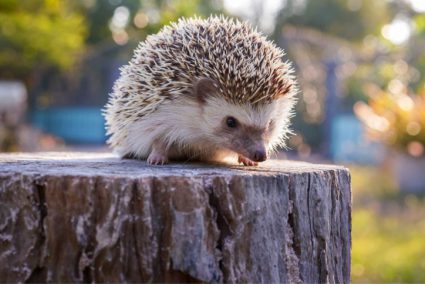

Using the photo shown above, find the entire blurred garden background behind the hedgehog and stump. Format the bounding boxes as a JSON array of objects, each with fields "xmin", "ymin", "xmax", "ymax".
[{"xmin": 0, "ymin": 0, "xmax": 425, "ymax": 283}]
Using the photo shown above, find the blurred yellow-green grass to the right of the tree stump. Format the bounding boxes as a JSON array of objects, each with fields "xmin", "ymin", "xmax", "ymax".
[{"xmin": 349, "ymin": 166, "xmax": 425, "ymax": 283}]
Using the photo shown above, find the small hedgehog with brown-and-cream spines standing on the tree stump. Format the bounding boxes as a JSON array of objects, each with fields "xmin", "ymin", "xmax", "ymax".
[{"xmin": 104, "ymin": 16, "xmax": 296, "ymax": 166}]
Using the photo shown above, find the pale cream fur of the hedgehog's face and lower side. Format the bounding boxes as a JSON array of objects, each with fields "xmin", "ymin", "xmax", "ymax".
[{"xmin": 121, "ymin": 92, "xmax": 294, "ymax": 161}]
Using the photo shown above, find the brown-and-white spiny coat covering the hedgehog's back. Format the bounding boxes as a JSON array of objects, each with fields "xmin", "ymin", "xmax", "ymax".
[{"xmin": 103, "ymin": 15, "xmax": 297, "ymax": 158}]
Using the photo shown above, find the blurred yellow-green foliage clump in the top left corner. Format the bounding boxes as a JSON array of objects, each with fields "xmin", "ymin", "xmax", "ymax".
[{"xmin": 0, "ymin": 0, "xmax": 86, "ymax": 79}]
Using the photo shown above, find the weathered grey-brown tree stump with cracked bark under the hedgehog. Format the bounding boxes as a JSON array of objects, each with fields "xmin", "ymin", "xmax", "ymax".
[{"xmin": 0, "ymin": 153, "xmax": 351, "ymax": 283}]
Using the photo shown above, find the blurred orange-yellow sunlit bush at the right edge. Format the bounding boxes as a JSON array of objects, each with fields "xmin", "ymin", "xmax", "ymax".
[{"xmin": 346, "ymin": 11, "xmax": 425, "ymax": 156}]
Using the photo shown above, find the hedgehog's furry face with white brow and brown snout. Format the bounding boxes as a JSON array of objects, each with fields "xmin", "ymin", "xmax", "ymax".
[{"xmin": 201, "ymin": 96, "xmax": 292, "ymax": 162}]
